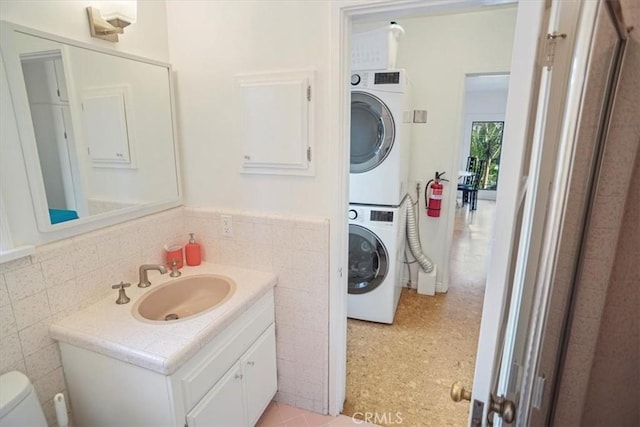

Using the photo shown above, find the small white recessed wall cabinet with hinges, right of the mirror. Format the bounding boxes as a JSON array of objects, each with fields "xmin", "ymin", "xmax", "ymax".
[{"xmin": 236, "ymin": 71, "xmax": 315, "ymax": 175}]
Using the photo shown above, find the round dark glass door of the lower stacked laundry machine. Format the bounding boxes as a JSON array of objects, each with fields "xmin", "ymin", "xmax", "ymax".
[{"xmin": 349, "ymin": 224, "xmax": 389, "ymax": 294}]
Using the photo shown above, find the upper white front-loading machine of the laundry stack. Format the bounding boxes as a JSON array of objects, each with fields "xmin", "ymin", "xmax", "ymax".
[{"xmin": 349, "ymin": 70, "xmax": 413, "ymax": 206}]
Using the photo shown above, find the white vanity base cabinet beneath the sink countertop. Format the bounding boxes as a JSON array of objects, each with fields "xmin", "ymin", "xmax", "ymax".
[{"xmin": 60, "ymin": 291, "xmax": 277, "ymax": 427}]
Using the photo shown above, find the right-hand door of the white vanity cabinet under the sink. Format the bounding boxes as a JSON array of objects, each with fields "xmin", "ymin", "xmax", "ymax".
[{"xmin": 240, "ymin": 324, "xmax": 278, "ymax": 425}]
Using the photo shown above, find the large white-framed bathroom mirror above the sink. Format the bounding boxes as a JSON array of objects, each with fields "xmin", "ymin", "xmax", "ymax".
[{"xmin": 0, "ymin": 22, "xmax": 180, "ymax": 236}]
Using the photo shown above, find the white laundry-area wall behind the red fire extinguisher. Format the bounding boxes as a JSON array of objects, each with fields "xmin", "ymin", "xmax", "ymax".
[{"xmin": 390, "ymin": 6, "xmax": 516, "ymax": 292}]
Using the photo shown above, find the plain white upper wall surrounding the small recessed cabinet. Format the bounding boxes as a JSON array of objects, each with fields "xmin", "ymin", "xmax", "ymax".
[{"xmin": 167, "ymin": 1, "xmax": 332, "ymax": 217}]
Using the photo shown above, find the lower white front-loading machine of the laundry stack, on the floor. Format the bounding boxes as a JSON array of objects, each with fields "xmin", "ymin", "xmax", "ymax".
[{"xmin": 347, "ymin": 201, "xmax": 407, "ymax": 323}]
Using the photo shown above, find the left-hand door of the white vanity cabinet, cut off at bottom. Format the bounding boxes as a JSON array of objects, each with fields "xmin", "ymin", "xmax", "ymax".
[{"xmin": 187, "ymin": 363, "xmax": 247, "ymax": 427}]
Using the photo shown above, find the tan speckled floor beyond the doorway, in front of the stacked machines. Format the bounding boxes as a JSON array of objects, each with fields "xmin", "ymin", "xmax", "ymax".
[{"xmin": 343, "ymin": 201, "xmax": 495, "ymax": 427}]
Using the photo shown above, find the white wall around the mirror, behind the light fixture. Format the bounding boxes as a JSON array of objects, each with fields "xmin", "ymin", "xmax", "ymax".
[{"xmin": 0, "ymin": 0, "xmax": 169, "ymax": 246}]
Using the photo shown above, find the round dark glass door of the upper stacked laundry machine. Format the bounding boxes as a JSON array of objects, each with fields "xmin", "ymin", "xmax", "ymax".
[{"xmin": 350, "ymin": 91, "xmax": 396, "ymax": 173}]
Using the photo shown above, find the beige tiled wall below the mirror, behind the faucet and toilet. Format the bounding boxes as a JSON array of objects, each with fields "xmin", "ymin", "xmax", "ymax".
[{"xmin": 0, "ymin": 208, "xmax": 184, "ymax": 425}]
